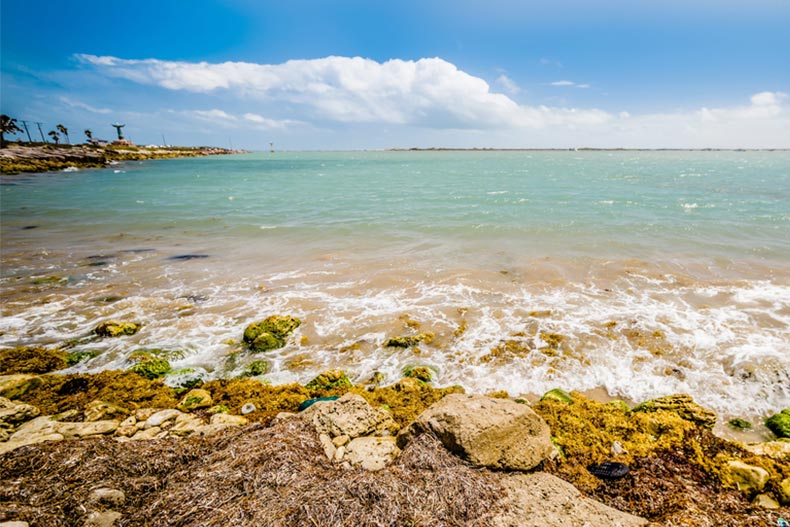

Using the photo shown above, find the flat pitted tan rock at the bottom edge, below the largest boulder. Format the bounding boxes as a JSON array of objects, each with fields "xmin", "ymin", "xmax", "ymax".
[{"xmin": 491, "ymin": 472, "xmax": 648, "ymax": 527}]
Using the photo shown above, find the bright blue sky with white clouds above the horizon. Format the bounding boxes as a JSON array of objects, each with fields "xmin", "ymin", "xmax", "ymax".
[{"xmin": 0, "ymin": 0, "xmax": 790, "ymax": 150}]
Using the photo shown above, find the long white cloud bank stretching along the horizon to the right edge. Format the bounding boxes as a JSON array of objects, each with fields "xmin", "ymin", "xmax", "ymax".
[{"xmin": 76, "ymin": 54, "xmax": 790, "ymax": 148}]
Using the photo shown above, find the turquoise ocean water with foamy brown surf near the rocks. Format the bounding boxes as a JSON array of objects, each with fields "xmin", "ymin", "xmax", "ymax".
[{"xmin": 0, "ymin": 151, "xmax": 790, "ymax": 428}]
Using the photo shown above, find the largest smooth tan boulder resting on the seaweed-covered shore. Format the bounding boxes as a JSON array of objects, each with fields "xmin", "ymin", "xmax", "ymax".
[{"xmin": 398, "ymin": 394, "xmax": 554, "ymax": 470}]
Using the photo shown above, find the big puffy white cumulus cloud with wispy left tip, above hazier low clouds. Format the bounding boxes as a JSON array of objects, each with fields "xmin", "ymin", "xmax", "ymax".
[{"xmin": 77, "ymin": 55, "xmax": 611, "ymax": 129}]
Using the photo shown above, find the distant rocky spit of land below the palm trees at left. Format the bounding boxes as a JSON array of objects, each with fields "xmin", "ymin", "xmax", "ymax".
[{"xmin": 0, "ymin": 143, "xmax": 241, "ymax": 174}]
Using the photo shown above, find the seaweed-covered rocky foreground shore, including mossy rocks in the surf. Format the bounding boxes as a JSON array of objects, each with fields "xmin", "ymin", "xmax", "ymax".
[{"xmin": 0, "ymin": 315, "xmax": 790, "ymax": 527}]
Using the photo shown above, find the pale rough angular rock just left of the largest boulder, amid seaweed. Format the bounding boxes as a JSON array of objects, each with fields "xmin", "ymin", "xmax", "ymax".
[{"xmin": 300, "ymin": 393, "xmax": 397, "ymax": 438}]
